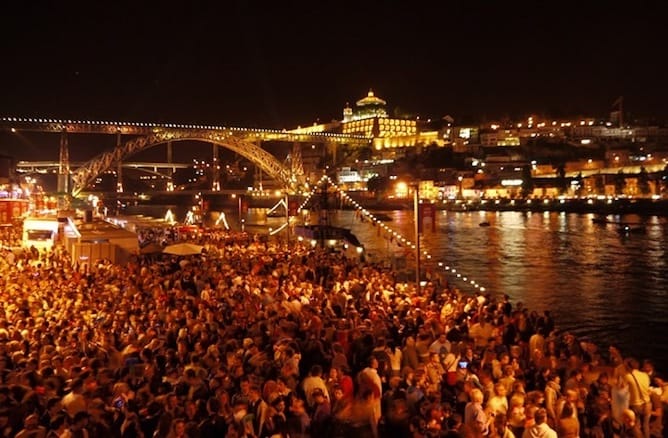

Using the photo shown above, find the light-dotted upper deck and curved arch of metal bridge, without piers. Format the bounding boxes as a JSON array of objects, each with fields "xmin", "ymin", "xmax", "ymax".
[{"xmin": 0, "ymin": 117, "xmax": 370, "ymax": 196}]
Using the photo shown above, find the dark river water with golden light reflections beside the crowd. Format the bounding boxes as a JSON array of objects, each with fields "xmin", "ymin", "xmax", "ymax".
[{"xmin": 122, "ymin": 204, "xmax": 668, "ymax": 371}]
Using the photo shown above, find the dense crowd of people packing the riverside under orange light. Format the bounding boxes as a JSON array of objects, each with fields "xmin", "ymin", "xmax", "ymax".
[{"xmin": 0, "ymin": 221, "xmax": 668, "ymax": 438}]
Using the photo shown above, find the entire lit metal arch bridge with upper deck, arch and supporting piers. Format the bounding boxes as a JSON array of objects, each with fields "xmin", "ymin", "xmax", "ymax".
[{"xmin": 0, "ymin": 117, "xmax": 371, "ymax": 196}]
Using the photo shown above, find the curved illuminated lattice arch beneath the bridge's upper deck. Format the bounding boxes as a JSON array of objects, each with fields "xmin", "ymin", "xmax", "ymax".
[{"xmin": 72, "ymin": 129, "xmax": 299, "ymax": 196}]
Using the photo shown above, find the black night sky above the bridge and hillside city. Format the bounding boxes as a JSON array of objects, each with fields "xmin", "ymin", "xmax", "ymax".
[{"xmin": 0, "ymin": 0, "xmax": 668, "ymax": 128}]
